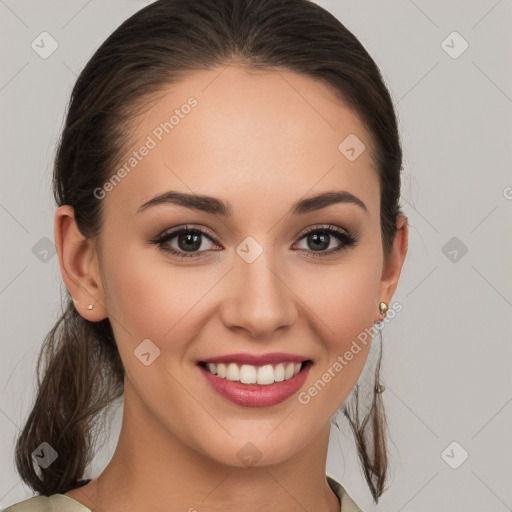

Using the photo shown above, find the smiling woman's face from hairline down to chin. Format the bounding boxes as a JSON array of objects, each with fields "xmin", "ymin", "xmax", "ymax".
[{"xmin": 63, "ymin": 66, "xmax": 404, "ymax": 466}]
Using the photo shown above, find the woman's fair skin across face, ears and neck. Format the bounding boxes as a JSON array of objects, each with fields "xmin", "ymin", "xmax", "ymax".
[{"xmin": 55, "ymin": 66, "xmax": 408, "ymax": 512}]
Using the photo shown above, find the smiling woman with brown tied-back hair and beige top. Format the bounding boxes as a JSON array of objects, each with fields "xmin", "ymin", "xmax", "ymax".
[{"xmin": 7, "ymin": 0, "xmax": 408, "ymax": 512}]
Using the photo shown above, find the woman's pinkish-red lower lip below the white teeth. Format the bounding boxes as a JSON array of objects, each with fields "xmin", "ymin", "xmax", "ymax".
[{"xmin": 198, "ymin": 363, "xmax": 311, "ymax": 407}]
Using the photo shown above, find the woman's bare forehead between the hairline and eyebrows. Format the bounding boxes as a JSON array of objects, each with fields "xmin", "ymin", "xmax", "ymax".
[{"xmin": 102, "ymin": 66, "xmax": 378, "ymax": 220}]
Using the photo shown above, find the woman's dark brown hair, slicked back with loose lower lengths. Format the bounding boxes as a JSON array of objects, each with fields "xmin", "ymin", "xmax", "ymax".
[{"xmin": 15, "ymin": 0, "xmax": 402, "ymax": 502}]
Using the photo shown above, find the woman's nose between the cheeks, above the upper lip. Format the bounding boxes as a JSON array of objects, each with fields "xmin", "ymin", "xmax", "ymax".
[{"xmin": 221, "ymin": 251, "xmax": 298, "ymax": 340}]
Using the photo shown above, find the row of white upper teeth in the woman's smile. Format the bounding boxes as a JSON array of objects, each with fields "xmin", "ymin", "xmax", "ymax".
[{"xmin": 207, "ymin": 362, "xmax": 302, "ymax": 385}]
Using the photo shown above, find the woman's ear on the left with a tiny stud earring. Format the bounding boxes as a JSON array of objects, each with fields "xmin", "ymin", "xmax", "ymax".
[{"xmin": 54, "ymin": 205, "xmax": 108, "ymax": 322}]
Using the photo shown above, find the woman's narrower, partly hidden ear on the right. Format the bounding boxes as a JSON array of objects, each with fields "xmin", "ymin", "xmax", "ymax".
[{"xmin": 376, "ymin": 214, "xmax": 409, "ymax": 320}]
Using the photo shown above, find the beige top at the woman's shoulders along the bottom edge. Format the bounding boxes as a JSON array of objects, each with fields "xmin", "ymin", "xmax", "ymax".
[{"xmin": 0, "ymin": 475, "xmax": 362, "ymax": 512}]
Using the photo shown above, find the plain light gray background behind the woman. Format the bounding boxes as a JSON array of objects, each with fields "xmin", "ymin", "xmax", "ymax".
[{"xmin": 0, "ymin": 0, "xmax": 512, "ymax": 512}]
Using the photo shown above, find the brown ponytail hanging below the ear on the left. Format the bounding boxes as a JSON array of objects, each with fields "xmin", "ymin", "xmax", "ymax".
[{"xmin": 15, "ymin": 300, "xmax": 124, "ymax": 496}]
